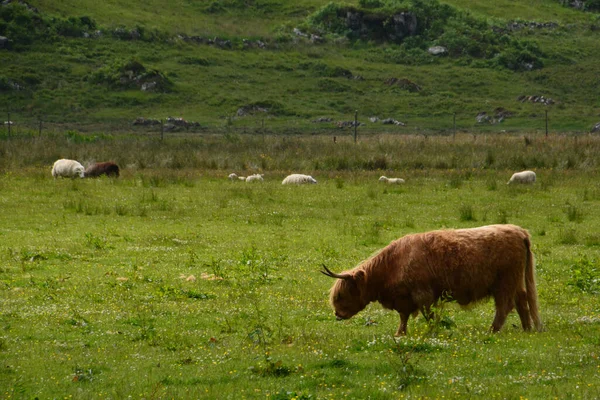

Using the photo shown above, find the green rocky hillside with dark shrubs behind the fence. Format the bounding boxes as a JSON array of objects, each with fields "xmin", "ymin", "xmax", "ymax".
[{"xmin": 0, "ymin": 0, "xmax": 600, "ymax": 131}]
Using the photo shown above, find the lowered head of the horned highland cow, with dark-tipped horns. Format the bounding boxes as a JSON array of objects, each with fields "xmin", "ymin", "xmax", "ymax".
[{"xmin": 321, "ymin": 265, "xmax": 368, "ymax": 319}]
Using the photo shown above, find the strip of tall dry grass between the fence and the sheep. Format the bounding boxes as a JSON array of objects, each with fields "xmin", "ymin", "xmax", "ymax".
[{"xmin": 0, "ymin": 132, "xmax": 600, "ymax": 173}]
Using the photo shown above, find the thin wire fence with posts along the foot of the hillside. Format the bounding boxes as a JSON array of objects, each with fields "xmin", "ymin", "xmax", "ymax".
[{"xmin": 0, "ymin": 110, "xmax": 600, "ymax": 140}]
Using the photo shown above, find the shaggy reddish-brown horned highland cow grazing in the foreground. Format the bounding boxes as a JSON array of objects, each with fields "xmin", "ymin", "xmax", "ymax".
[{"xmin": 321, "ymin": 225, "xmax": 542, "ymax": 336}]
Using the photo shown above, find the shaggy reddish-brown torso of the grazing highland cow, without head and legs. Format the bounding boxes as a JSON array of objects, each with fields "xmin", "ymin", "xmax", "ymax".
[{"xmin": 391, "ymin": 225, "xmax": 529, "ymax": 304}]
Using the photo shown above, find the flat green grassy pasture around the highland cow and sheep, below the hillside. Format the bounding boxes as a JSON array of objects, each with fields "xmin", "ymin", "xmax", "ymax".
[{"xmin": 0, "ymin": 136, "xmax": 600, "ymax": 399}]
